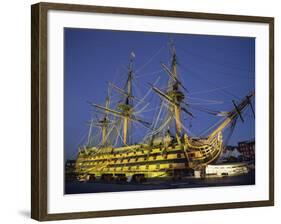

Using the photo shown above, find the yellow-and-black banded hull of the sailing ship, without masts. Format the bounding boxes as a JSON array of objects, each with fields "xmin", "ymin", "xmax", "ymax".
[{"xmin": 75, "ymin": 133, "xmax": 222, "ymax": 182}]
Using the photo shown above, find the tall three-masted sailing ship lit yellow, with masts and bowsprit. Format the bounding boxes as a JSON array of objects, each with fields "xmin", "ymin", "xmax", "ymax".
[{"xmin": 75, "ymin": 41, "xmax": 254, "ymax": 182}]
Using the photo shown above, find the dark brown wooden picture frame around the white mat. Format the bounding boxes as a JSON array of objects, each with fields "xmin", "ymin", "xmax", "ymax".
[{"xmin": 31, "ymin": 3, "xmax": 274, "ymax": 221}]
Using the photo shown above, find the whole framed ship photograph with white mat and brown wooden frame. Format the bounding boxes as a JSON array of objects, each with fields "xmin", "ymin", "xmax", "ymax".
[{"xmin": 31, "ymin": 3, "xmax": 274, "ymax": 221}]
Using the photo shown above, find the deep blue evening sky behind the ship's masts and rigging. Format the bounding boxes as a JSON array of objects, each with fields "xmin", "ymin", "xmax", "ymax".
[{"xmin": 64, "ymin": 28, "xmax": 255, "ymax": 159}]
